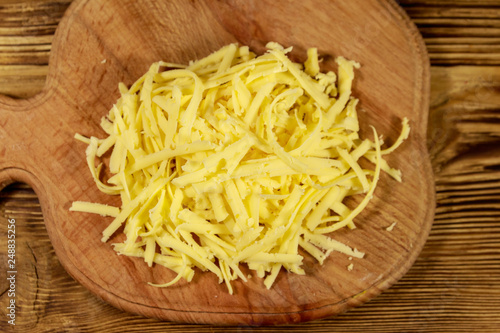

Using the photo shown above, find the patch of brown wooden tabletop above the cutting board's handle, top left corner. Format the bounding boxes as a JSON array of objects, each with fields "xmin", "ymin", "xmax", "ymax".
[{"xmin": 0, "ymin": 0, "xmax": 71, "ymax": 98}]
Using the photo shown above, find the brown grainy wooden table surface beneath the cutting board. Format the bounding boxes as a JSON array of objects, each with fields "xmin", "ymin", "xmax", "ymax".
[{"xmin": 0, "ymin": 0, "xmax": 500, "ymax": 332}]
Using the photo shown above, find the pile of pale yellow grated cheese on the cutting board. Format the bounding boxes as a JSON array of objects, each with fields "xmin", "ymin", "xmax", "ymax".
[{"xmin": 71, "ymin": 43, "xmax": 410, "ymax": 294}]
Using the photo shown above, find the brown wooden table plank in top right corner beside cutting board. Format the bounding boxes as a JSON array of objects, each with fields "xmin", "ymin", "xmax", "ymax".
[{"xmin": 400, "ymin": 1, "xmax": 500, "ymax": 65}]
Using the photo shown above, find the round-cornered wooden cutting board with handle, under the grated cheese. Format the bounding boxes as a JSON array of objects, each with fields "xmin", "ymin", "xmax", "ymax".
[{"xmin": 0, "ymin": 0, "xmax": 435, "ymax": 325}]
